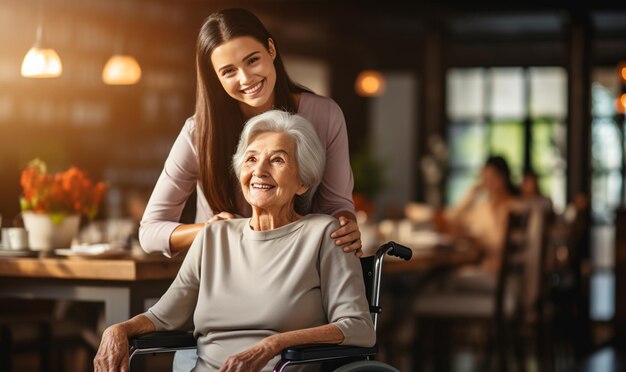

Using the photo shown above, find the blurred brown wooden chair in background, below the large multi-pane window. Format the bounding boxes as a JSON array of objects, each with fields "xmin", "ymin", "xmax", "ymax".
[{"xmin": 413, "ymin": 209, "xmax": 544, "ymax": 371}]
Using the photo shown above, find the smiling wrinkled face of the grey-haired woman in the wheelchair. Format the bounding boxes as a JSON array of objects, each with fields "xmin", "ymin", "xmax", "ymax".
[{"xmin": 239, "ymin": 132, "xmax": 307, "ymax": 213}]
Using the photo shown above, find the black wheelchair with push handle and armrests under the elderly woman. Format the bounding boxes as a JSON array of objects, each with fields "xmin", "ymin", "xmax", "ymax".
[{"xmin": 129, "ymin": 241, "xmax": 412, "ymax": 372}]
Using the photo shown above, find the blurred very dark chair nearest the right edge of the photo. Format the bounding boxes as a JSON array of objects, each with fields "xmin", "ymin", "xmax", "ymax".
[{"xmin": 536, "ymin": 202, "xmax": 593, "ymax": 372}]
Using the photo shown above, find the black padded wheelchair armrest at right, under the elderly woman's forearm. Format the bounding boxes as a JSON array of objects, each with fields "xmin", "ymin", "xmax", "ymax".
[{"xmin": 281, "ymin": 344, "xmax": 378, "ymax": 362}]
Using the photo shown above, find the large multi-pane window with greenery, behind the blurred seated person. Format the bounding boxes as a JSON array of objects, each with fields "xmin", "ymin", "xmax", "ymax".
[{"xmin": 445, "ymin": 67, "xmax": 567, "ymax": 211}]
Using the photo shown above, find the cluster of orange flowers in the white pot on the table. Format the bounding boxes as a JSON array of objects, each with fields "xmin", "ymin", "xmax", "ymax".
[{"xmin": 20, "ymin": 159, "xmax": 106, "ymax": 218}]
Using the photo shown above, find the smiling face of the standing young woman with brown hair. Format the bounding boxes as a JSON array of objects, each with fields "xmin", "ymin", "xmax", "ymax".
[{"xmin": 211, "ymin": 36, "xmax": 276, "ymax": 116}]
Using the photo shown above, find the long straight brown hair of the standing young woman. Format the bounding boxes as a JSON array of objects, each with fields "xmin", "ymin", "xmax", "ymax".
[{"xmin": 194, "ymin": 9, "xmax": 306, "ymax": 213}]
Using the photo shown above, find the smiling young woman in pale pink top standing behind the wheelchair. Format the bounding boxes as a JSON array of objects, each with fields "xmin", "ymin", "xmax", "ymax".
[{"xmin": 139, "ymin": 9, "xmax": 361, "ymax": 256}]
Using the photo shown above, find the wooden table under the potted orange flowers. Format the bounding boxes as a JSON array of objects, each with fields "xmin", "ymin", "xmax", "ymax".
[{"xmin": 0, "ymin": 254, "xmax": 182, "ymax": 325}]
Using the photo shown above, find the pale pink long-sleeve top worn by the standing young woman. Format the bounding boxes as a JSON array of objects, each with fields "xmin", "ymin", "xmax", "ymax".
[{"xmin": 139, "ymin": 93, "xmax": 354, "ymax": 257}]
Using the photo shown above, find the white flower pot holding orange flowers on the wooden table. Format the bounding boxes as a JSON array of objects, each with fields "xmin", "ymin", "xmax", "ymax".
[{"xmin": 22, "ymin": 211, "xmax": 80, "ymax": 251}]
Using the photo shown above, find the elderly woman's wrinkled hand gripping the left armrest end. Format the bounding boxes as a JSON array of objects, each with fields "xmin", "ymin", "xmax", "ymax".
[{"xmin": 93, "ymin": 325, "xmax": 129, "ymax": 372}]
